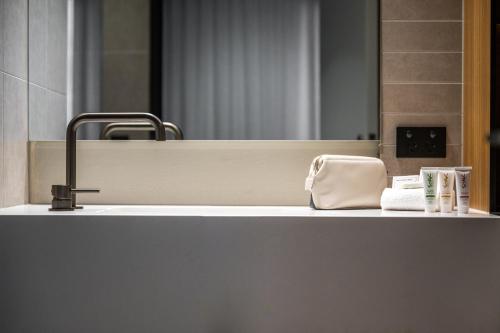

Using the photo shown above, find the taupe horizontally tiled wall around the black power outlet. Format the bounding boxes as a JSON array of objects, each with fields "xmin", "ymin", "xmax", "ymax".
[{"xmin": 380, "ymin": 0, "xmax": 463, "ymax": 176}]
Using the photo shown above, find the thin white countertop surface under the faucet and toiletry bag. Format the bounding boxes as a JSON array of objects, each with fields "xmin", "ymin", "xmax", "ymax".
[{"xmin": 0, "ymin": 205, "xmax": 494, "ymax": 220}]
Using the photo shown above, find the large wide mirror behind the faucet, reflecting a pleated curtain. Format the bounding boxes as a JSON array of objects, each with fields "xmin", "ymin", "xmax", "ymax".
[{"xmin": 30, "ymin": 0, "xmax": 379, "ymax": 140}]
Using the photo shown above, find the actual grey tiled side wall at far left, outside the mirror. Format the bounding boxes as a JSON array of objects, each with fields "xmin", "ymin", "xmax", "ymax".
[{"xmin": 0, "ymin": 0, "xmax": 28, "ymax": 207}]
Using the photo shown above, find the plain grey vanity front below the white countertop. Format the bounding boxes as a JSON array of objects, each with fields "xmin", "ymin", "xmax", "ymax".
[{"xmin": 0, "ymin": 216, "xmax": 500, "ymax": 333}]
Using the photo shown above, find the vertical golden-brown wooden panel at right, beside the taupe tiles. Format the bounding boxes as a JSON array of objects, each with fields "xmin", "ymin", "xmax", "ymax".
[{"xmin": 463, "ymin": 0, "xmax": 491, "ymax": 211}]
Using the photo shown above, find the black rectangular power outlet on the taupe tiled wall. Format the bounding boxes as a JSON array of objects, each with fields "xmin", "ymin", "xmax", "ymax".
[{"xmin": 396, "ymin": 127, "xmax": 446, "ymax": 158}]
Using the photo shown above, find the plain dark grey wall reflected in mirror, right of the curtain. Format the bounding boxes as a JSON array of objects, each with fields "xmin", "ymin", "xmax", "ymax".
[{"xmin": 321, "ymin": 0, "xmax": 379, "ymax": 140}]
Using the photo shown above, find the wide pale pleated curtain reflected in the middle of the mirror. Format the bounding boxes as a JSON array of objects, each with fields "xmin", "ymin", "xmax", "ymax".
[{"xmin": 163, "ymin": 0, "xmax": 320, "ymax": 140}]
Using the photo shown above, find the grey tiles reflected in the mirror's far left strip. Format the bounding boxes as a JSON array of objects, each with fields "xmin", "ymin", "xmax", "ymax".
[{"xmin": 28, "ymin": 0, "xmax": 68, "ymax": 140}]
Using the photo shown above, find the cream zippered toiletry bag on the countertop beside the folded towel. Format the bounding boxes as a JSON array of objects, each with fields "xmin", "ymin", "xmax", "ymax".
[{"xmin": 305, "ymin": 155, "xmax": 387, "ymax": 209}]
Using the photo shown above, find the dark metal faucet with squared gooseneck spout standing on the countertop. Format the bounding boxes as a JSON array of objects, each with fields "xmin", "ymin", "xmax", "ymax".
[{"xmin": 49, "ymin": 113, "xmax": 166, "ymax": 211}]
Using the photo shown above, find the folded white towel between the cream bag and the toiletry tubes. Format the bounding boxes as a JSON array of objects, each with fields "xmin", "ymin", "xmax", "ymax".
[{"xmin": 380, "ymin": 188, "xmax": 425, "ymax": 210}]
